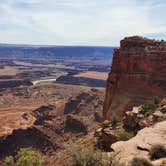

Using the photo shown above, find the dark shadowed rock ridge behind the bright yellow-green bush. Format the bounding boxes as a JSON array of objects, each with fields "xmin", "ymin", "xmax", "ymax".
[{"xmin": 0, "ymin": 127, "xmax": 57, "ymax": 159}]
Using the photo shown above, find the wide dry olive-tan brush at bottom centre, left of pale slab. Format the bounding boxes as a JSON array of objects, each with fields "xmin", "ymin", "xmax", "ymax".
[{"xmin": 66, "ymin": 144, "xmax": 118, "ymax": 166}]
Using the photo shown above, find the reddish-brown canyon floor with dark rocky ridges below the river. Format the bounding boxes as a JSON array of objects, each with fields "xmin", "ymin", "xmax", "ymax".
[{"xmin": 0, "ymin": 83, "xmax": 104, "ymax": 166}]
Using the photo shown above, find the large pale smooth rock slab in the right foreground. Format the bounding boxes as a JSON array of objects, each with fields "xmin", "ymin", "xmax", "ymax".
[{"xmin": 111, "ymin": 121, "xmax": 166, "ymax": 163}]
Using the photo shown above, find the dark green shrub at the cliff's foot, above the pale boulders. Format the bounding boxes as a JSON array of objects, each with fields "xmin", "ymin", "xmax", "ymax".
[{"xmin": 141, "ymin": 100, "xmax": 157, "ymax": 115}]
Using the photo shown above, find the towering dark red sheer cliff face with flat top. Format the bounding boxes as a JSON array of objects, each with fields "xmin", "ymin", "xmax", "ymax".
[{"xmin": 103, "ymin": 36, "xmax": 166, "ymax": 119}]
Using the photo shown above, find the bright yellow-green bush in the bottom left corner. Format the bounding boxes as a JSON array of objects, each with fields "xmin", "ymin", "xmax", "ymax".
[{"xmin": 3, "ymin": 148, "xmax": 42, "ymax": 166}]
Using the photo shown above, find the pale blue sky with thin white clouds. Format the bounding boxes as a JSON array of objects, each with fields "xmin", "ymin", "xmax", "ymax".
[{"xmin": 0, "ymin": 0, "xmax": 166, "ymax": 46}]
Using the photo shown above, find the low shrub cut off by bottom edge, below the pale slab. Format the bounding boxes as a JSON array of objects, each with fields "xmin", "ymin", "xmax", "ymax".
[{"xmin": 130, "ymin": 157, "xmax": 152, "ymax": 166}]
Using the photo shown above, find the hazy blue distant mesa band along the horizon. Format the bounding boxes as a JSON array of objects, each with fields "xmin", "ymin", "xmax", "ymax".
[{"xmin": 0, "ymin": 44, "xmax": 115, "ymax": 59}]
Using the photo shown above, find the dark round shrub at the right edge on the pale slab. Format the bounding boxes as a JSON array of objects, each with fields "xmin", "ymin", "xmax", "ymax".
[{"xmin": 149, "ymin": 145, "xmax": 166, "ymax": 160}]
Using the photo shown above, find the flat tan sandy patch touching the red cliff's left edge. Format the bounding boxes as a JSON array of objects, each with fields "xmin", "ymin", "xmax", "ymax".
[{"xmin": 74, "ymin": 71, "xmax": 108, "ymax": 80}]
